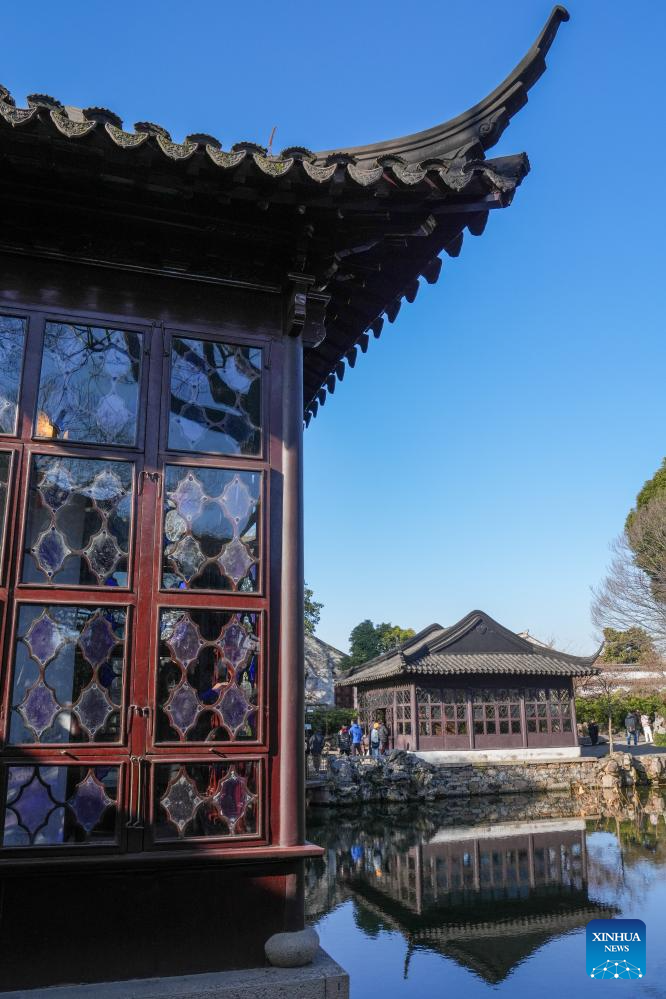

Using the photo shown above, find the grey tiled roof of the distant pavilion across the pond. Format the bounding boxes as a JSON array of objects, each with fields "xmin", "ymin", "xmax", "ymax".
[{"xmin": 338, "ymin": 610, "xmax": 599, "ymax": 686}]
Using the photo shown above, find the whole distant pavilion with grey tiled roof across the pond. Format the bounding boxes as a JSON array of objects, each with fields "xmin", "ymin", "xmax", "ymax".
[{"xmin": 338, "ymin": 611, "xmax": 599, "ymax": 758}]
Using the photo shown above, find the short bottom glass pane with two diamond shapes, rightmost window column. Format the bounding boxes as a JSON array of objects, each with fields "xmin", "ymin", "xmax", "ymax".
[{"xmin": 154, "ymin": 760, "xmax": 259, "ymax": 839}]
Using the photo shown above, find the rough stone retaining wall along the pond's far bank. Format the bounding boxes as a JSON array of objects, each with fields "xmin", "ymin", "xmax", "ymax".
[{"xmin": 308, "ymin": 750, "xmax": 666, "ymax": 805}]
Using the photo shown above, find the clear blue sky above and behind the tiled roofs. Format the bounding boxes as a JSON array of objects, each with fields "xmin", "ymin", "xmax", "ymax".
[{"xmin": 0, "ymin": 0, "xmax": 666, "ymax": 652}]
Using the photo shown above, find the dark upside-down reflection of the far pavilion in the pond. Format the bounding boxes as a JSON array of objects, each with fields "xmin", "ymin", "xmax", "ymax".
[{"xmin": 306, "ymin": 803, "xmax": 618, "ymax": 984}]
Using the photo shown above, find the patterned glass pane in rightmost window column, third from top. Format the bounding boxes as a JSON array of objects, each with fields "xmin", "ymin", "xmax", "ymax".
[{"xmin": 156, "ymin": 608, "xmax": 260, "ymax": 742}]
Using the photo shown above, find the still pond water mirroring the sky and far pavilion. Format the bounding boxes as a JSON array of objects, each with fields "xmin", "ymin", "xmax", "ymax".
[{"xmin": 306, "ymin": 793, "xmax": 666, "ymax": 999}]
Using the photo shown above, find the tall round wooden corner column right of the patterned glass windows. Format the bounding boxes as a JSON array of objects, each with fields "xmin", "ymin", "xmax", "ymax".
[{"xmin": 278, "ymin": 327, "xmax": 305, "ymax": 846}]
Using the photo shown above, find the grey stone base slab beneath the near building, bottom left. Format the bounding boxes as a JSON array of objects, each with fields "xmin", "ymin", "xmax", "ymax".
[{"xmin": 0, "ymin": 948, "xmax": 349, "ymax": 999}]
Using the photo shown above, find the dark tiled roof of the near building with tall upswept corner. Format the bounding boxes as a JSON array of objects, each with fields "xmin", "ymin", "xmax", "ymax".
[{"xmin": 0, "ymin": 6, "xmax": 569, "ymax": 422}]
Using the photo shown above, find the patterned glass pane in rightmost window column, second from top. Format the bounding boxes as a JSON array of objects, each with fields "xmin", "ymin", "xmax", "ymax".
[{"xmin": 162, "ymin": 465, "xmax": 261, "ymax": 593}]
